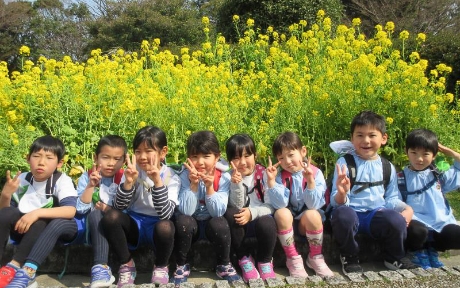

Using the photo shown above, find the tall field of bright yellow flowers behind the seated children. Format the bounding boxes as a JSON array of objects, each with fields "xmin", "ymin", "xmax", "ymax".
[{"xmin": 0, "ymin": 10, "xmax": 460, "ymax": 181}]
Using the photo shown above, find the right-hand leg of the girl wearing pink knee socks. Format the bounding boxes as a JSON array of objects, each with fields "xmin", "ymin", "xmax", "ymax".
[{"xmin": 299, "ymin": 210, "xmax": 323, "ymax": 258}]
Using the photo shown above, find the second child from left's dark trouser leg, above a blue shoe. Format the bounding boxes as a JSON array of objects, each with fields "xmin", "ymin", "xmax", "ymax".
[{"xmin": 88, "ymin": 209, "xmax": 109, "ymax": 265}]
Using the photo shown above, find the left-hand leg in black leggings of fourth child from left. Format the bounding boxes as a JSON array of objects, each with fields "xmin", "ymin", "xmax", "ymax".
[{"xmin": 174, "ymin": 215, "xmax": 198, "ymax": 266}]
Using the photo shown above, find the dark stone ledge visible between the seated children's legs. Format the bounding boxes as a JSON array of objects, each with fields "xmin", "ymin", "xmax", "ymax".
[{"xmin": 2, "ymin": 233, "xmax": 382, "ymax": 273}]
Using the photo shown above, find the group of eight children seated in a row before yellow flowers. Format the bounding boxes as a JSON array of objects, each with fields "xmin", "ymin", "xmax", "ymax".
[{"xmin": 0, "ymin": 111, "xmax": 460, "ymax": 287}]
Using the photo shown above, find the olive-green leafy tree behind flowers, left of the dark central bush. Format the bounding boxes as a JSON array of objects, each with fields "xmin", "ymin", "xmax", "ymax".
[{"xmin": 89, "ymin": 0, "xmax": 202, "ymax": 51}]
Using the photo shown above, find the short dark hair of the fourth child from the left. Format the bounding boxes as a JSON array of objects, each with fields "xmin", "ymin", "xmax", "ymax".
[{"xmin": 187, "ymin": 130, "xmax": 220, "ymax": 156}]
